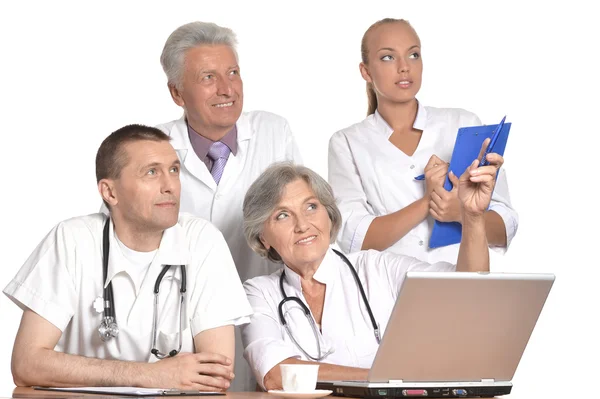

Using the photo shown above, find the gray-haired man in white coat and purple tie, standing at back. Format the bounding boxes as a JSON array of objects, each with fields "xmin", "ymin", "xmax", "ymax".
[{"xmin": 157, "ymin": 22, "xmax": 302, "ymax": 391}]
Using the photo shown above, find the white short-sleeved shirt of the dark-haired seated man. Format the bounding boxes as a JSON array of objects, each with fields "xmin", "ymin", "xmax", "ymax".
[{"xmin": 4, "ymin": 214, "xmax": 252, "ymax": 362}]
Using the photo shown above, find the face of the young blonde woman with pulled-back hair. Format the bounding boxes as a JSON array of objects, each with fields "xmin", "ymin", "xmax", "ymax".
[{"xmin": 360, "ymin": 22, "xmax": 423, "ymax": 104}]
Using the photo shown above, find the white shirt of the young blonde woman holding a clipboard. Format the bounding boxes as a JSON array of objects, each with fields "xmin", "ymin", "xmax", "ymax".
[{"xmin": 329, "ymin": 103, "xmax": 518, "ymax": 263}]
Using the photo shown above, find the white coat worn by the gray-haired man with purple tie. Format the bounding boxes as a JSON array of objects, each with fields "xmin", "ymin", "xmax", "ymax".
[{"xmin": 157, "ymin": 111, "xmax": 302, "ymax": 391}]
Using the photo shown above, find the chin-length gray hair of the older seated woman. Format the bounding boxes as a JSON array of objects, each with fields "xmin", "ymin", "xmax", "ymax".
[{"xmin": 243, "ymin": 162, "xmax": 342, "ymax": 263}]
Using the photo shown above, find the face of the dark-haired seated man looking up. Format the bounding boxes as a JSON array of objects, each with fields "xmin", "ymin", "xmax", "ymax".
[{"xmin": 111, "ymin": 140, "xmax": 181, "ymax": 232}]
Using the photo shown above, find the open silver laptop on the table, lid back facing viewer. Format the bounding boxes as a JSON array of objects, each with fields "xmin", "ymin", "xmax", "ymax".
[{"xmin": 317, "ymin": 272, "xmax": 554, "ymax": 398}]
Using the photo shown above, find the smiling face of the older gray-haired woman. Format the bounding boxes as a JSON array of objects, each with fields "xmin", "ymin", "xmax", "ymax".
[{"xmin": 260, "ymin": 179, "xmax": 331, "ymax": 274}]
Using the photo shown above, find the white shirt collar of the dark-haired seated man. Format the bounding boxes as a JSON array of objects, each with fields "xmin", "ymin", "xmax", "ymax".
[{"xmin": 104, "ymin": 219, "xmax": 190, "ymax": 288}]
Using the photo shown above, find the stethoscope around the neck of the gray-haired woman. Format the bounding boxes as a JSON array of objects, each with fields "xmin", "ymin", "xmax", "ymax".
[{"xmin": 278, "ymin": 248, "xmax": 381, "ymax": 362}]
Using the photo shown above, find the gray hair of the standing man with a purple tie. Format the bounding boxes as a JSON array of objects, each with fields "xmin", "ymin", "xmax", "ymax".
[{"xmin": 160, "ymin": 21, "xmax": 238, "ymax": 89}]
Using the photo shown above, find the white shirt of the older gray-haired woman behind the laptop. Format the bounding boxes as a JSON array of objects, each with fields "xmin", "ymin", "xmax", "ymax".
[{"xmin": 242, "ymin": 249, "xmax": 455, "ymax": 387}]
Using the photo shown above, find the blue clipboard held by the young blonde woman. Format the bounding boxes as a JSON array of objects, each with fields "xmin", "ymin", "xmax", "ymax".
[{"xmin": 429, "ymin": 122, "xmax": 511, "ymax": 248}]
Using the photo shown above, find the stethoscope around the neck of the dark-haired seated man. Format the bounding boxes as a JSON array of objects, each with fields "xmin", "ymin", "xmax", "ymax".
[{"xmin": 98, "ymin": 218, "xmax": 186, "ymax": 359}]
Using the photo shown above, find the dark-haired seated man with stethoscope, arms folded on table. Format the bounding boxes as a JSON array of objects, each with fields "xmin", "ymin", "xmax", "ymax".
[{"xmin": 4, "ymin": 125, "xmax": 252, "ymax": 391}]
